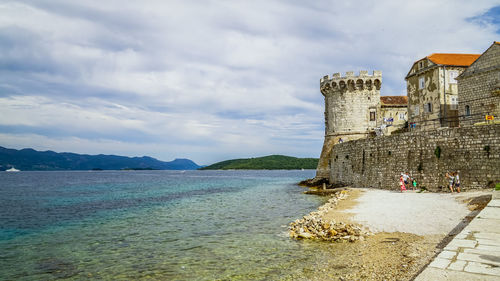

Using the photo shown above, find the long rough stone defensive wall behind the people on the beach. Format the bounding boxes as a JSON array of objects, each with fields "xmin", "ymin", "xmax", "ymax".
[{"xmin": 329, "ymin": 124, "xmax": 500, "ymax": 191}]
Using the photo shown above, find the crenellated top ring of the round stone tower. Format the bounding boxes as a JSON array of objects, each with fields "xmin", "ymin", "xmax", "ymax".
[{"xmin": 320, "ymin": 70, "xmax": 382, "ymax": 95}]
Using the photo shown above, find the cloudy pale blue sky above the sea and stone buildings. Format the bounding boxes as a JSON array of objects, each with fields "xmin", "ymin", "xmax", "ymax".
[{"xmin": 0, "ymin": 0, "xmax": 500, "ymax": 165}]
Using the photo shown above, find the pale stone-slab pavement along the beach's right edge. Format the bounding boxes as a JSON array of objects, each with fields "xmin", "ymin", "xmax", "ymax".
[{"xmin": 415, "ymin": 191, "xmax": 500, "ymax": 281}]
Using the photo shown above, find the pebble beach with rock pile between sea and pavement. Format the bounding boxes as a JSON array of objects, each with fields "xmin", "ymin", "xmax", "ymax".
[{"xmin": 284, "ymin": 185, "xmax": 489, "ymax": 280}]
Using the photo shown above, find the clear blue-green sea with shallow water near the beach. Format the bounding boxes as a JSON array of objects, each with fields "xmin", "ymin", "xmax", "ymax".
[{"xmin": 0, "ymin": 170, "xmax": 356, "ymax": 280}]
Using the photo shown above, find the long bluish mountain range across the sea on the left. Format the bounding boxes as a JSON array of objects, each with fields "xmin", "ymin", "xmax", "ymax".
[{"xmin": 0, "ymin": 146, "xmax": 201, "ymax": 171}]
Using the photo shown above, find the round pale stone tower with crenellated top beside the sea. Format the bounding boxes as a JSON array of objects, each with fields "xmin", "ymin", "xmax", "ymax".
[{"xmin": 315, "ymin": 70, "xmax": 382, "ymax": 180}]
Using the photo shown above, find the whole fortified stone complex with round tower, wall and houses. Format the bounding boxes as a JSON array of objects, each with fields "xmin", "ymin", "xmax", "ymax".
[{"xmin": 309, "ymin": 45, "xmax": 500, "ymax": 188}]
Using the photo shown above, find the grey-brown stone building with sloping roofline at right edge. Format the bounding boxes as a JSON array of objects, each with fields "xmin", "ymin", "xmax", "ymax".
[{"xmin": 457, "ymin": 42, "xmax": 500, "ymax": 126}]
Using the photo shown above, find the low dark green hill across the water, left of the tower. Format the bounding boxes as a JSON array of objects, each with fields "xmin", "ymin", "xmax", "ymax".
[{"xmin": 200, "ymin": 155, "xmax": 318, "ymax": 170}]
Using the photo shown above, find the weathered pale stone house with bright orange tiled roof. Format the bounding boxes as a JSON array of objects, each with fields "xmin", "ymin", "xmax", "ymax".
[{"xmin": 405, "ymin": 53, "xmax": 479, "ymax": 130}]
